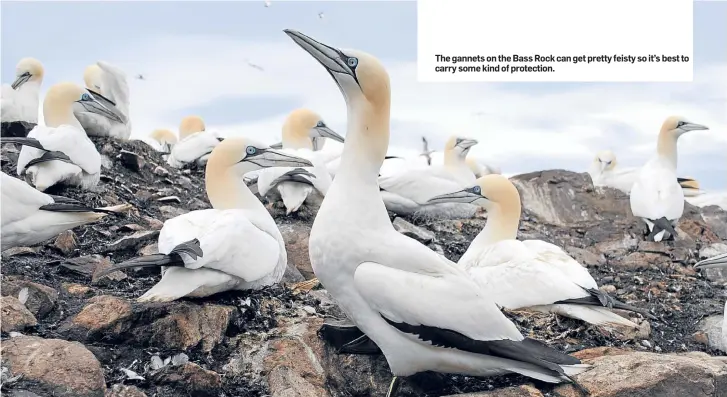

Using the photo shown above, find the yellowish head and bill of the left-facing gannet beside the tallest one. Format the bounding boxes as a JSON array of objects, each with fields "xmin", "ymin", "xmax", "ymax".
[{"xmin": 427, "ymin": 174, "xmax": 520, "ymax": 210}]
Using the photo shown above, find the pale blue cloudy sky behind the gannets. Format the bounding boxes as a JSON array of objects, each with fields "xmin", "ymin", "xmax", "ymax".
[{"xmin": 0, "ymin": 1, "xmax": 727, "ymax": 190}]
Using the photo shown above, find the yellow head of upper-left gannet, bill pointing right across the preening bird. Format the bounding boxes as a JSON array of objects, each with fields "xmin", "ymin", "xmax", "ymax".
[{"xmin": 43, "ymin": 83, "xmax": 121, "ymax": 127}]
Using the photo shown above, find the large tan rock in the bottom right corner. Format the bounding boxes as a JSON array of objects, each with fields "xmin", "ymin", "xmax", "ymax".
[{"xmin": 555, "ymin": 352, "xmax": 727, "ymax": 397}]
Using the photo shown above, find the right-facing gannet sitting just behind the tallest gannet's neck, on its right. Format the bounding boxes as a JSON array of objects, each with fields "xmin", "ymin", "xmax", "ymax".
[{"xmin": 379, "ymin": 136, "xmax": 477, "ymax": 217}]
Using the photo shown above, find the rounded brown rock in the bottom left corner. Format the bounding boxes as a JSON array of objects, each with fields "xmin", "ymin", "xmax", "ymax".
[{"xmin": 2, "ymin": 336, "xmax": 106, "ymax": 397}]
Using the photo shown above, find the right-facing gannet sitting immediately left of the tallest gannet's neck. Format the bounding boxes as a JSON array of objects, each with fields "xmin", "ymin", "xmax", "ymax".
[{"xmin": 257, "ymin": 109, "xmax": 344, "ymax": 215}]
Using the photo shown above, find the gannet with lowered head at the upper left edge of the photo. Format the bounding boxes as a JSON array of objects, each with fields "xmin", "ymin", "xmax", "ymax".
[{"xmin": 0, "ymin": 58, "xmax": 44, "ymax": 136}]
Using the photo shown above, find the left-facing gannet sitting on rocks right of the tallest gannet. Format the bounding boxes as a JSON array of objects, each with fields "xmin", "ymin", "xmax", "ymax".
[{"xmin": 430, "ymin": 174, "xmax": 653, "ymax": 328}]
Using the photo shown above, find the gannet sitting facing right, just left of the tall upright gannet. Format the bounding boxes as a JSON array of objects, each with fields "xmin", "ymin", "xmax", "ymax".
[{"xmin": 96, "ymin": 138, "xmax": 311, "ymax": 302}]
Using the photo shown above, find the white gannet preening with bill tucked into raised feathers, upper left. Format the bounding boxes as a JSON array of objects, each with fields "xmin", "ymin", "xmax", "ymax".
[{"xmin": 76, "ymin": 61, "xmax": 131, "ymax": 139}]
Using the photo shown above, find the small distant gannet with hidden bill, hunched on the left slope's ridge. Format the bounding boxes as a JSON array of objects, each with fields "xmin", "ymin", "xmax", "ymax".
[{"xmin": 167, "ymin": 116, "xmax": 222, "ymax": 168}]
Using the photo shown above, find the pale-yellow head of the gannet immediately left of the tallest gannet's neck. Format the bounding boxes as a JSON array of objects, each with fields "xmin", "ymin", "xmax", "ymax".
[{"xmin": 283, "ymin": 109, "xmax": 344, "ymax": 151}]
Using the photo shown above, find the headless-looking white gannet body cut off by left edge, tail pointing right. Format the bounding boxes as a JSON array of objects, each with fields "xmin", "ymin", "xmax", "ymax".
[{"xmin": 0, "ymin": 172, "xmax": 131, "ymax": 251}]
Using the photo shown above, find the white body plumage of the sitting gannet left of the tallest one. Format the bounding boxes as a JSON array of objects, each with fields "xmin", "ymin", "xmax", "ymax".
[{"xmin": 158, "ymin": 209, "xmax": 280, "ymax": 281}]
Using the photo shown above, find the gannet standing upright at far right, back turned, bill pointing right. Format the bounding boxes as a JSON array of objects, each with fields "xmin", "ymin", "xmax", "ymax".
[{"xmin": 630, "ymin": 117, "xmax": 708, "ymax": 241}]
